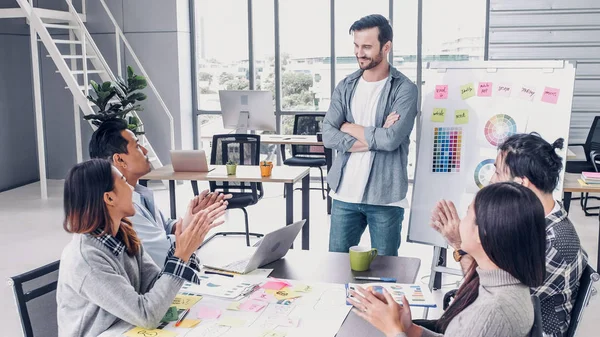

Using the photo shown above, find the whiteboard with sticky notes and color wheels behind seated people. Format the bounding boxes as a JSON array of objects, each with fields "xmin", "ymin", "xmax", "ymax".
[{"xmin": 407, "ymin": 61, "xmax": 575, "ymax": 247}]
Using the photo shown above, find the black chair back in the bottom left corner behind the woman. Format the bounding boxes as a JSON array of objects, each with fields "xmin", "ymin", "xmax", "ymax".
[{"xmin": 8, "ymin": 261, "xmax": 60, "ymax": 337}]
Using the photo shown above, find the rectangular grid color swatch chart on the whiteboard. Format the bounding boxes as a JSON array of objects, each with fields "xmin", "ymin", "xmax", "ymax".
[{"xmin": 431, "ymin": 127, "xmax": 463, "ymax": 173}]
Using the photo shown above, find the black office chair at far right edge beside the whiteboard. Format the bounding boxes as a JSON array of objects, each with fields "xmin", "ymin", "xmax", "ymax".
[{"xmin": 565, "ymin": 116, "xmax": 600, "ymax": 216}]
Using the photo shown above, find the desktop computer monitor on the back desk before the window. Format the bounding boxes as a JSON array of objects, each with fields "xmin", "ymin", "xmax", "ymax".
[{"xmin": 219, "ymin": 90, "xmax": 277, "ymax": 133}]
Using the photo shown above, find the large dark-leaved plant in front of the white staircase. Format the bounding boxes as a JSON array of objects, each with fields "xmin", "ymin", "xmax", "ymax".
[{"xmin": 83, "ymin": 66, "xmax": 148, "ymax": 135}]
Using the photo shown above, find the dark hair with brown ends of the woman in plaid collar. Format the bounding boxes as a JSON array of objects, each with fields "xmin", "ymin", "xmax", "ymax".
[{"xmin": 63, "ymin": 159, "xmax": 140, "ymax": 255}]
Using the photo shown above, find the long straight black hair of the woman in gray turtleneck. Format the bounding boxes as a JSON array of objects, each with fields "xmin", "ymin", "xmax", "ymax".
[{"xmin": 437, "ymin": 182, "xmax": 546, "ymax": 332}]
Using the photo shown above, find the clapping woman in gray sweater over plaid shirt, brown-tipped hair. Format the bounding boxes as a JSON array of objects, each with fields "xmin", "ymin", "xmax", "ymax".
[{"xmin": 56, "ymin": 159, "xmax": 225, "ymax": 337}]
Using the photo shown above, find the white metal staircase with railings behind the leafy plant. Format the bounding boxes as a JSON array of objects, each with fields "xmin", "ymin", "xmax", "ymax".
[{"xmin": 16, "ymin": 0, "xmax": 175, "ymax": 197}]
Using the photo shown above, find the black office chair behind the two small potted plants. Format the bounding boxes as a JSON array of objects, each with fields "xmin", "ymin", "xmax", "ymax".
[{"xmin": 192, "ymin": 134, "xmax": 264, "ymax": 247}]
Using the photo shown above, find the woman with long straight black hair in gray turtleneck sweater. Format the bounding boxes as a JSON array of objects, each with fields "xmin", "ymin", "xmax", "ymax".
[{"xmin": 352, "ymin": 183, "xmax": 546, "ymax": 337}]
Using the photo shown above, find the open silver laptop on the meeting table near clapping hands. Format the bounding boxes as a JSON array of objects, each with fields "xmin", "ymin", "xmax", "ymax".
[{"xmin": 204, "ymin": 220, "xmax": 306, "ymax": 274}]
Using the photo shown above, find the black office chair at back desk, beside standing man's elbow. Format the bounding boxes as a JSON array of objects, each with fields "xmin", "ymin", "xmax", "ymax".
[{"xmin": 281, "ymin": 114, "xmax": 327, "ymax": 200}]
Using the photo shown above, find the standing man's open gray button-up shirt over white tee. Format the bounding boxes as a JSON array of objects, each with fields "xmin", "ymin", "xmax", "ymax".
[{"xmin": 323, "ymin": 66, "xmax": 418, "ymax": 205}]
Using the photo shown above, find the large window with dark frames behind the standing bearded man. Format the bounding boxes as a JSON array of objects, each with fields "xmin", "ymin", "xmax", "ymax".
[{"xmin": 194, "ymin": 0, "xmax": 486, "ymax": 177}]
